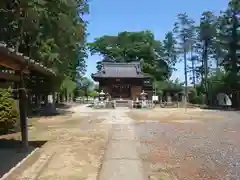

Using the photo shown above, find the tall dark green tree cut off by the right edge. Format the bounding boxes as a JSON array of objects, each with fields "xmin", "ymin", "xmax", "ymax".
[{"xmin": 218, "ymin": 0, "xmax": 240, "ymax": 107}]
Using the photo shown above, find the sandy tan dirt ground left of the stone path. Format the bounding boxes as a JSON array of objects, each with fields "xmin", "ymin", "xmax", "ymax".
[{"xmin": 5, "ymin": 109, "xmax": 108, "ymax": 180}]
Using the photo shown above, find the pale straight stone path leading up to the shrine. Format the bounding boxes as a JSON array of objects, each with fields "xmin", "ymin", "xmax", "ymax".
[{"xmin": 99, "ymin": 110, "xmax": 147, "ymax": 180}]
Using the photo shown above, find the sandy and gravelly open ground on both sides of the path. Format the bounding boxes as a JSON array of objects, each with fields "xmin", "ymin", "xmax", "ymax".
[{"xmin": 3, "ymin": 107, "xmax": 240, "ymax": 180}]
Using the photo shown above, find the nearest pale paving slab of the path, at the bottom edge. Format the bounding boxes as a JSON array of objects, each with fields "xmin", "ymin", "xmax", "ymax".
[{"xmin": 99, "ymin": 159, "xmax": 146, "ymax": 180}]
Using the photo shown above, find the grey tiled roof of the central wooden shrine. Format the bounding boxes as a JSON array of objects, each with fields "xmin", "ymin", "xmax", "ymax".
[{"xmin": 92, "ymin": 62, "xmax": 148, "ymax": 78}]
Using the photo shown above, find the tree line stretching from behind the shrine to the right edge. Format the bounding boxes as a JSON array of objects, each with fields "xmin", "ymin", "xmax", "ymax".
[{"xmin": 89, "ymin": 0, "xmax": 240, "ymax": 107}]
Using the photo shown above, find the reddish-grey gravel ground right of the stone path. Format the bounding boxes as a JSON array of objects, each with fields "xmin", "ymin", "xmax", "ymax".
[{"xmin": 130, "ymin": 111, "xmax": 240, "ymax": 180}]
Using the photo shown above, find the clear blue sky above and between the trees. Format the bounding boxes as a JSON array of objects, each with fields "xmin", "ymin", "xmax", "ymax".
[{"xmin": 86, "ymin": 0, "xmax": 228, "ymax": 80}]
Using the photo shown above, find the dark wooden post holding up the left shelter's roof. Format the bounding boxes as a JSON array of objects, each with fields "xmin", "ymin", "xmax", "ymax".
[{"xmin": 19, "ymin": 71, "xmax": 28, "ymax": 148}]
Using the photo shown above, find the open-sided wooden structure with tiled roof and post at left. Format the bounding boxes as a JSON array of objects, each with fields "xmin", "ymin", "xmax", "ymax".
[{"xmin": 0, "ymin": 43, "xmax": 56, "ymax": 147}]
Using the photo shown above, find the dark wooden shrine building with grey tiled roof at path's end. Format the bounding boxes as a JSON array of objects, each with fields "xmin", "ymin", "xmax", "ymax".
[{"xmin": 92, "ymin": 62, "xmax": 153, "ymax": 100}]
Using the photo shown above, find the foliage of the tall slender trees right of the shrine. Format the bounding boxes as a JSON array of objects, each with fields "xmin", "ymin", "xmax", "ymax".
[{"xmin": 171, "ymin": 0, "xmax": 240, "ymax": 107}]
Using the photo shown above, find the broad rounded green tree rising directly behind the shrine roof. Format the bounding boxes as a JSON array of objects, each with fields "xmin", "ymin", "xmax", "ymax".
[{"xmin": 89, "ymin": 31, "xmax": 171, "ymax": 80}]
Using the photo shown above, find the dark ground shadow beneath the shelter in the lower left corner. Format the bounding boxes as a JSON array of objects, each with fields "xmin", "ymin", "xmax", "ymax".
[{"xmin": 0, "ymin": 139, "xmax": 46, "ymax": 178}]
